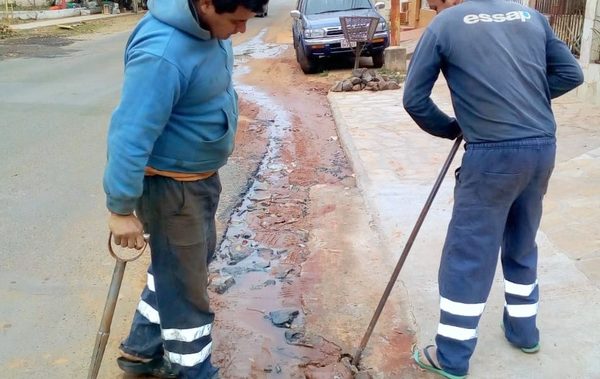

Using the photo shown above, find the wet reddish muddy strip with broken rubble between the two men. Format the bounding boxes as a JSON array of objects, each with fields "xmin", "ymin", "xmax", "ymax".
[{"xmin": 211, "ymin": 32, "xmax": 412, "ymax": 378}]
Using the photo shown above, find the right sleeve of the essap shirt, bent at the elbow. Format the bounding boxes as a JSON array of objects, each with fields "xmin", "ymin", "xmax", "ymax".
[{"xmin": 542, "ymin": 16, "xmax": 583, "ymax": 99}]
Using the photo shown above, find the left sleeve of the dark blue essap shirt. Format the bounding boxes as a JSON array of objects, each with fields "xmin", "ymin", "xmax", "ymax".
[{"xmin": 403, "ymin": 29, "xmax": 460, "ymax": 139}]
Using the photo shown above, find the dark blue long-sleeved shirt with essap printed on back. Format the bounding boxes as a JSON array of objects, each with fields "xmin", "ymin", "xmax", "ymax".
[{"xmin": 403, "ymin": 0, "xmax": 583, "ymax": 143}]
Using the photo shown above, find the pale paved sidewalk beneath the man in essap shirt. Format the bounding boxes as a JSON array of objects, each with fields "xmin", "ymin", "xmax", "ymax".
[{"xmin": 329, "ymin": 80, "xmax": 600, "ymax": 379}]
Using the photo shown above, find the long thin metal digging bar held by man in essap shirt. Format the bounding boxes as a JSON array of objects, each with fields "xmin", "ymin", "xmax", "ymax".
[{"xmin": 352, "ymin": 136, "xmax": 462, "ymax": 367}]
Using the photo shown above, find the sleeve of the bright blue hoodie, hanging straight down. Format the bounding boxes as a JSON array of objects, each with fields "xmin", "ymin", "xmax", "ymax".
[{"xmin": 104, "ymin": 50, "xmax": 185, "ymax": 215}]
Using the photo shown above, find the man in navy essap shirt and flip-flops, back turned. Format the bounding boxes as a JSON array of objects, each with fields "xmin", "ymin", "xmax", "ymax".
[{"xmin": 404, "ymin": 0, "xmax": 583, "ymax": 378}]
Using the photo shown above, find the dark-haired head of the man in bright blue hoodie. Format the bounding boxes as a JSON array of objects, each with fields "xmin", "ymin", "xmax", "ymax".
[{"xmin": 196, "ymin": 0, "xmax": 269, "ymax": 39}]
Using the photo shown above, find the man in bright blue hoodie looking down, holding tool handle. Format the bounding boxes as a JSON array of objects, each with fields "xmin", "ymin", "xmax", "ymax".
[{"xmin": 104, "ymin": 0, "xmax": 268, "ymax": 379}]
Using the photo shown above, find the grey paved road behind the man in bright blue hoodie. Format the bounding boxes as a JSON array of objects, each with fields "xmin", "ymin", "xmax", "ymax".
[{"xmin": 0, "ymin": 0, "xmax": 291, "ymax": 378}]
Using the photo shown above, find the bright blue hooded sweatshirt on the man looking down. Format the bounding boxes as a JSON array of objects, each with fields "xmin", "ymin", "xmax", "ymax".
[{"xmin": 104, "ymin": 0, "xmax": 238, "ymax": 215}]
